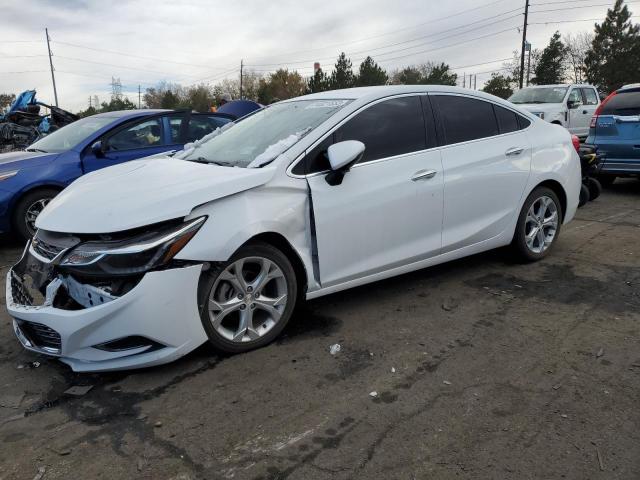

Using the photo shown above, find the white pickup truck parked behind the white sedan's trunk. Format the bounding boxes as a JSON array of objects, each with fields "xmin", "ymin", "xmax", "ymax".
[{"xmin": 509, "ymin": 84, "xmax": 600, "ymax": 138}]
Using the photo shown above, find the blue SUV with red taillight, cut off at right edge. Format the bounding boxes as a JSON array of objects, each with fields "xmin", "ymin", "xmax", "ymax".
[{"xmin": 586, "ymin": 83, "xmax": 640, "ymax": 184}]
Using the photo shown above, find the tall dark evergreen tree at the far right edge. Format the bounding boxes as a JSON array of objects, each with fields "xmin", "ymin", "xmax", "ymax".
[{"xmin": 584, "ymin": 0, "xmax": 640, "ymax": 93}]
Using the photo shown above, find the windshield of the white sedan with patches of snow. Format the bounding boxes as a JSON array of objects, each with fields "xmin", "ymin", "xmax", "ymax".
[{"xmin": 177, "ymin": 100, "xmax": 349, "ymax": 168}]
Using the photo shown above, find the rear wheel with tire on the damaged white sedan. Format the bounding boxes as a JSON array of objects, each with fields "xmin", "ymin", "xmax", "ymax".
[{"xmin": 511, "ymin": 187, "xmax": 562, "ymax": 262}]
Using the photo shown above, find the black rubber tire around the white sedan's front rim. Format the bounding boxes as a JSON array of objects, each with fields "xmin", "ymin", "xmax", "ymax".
[{"xmin": 198, "ymin": 242, "xmax": 298, "ymax": 353}]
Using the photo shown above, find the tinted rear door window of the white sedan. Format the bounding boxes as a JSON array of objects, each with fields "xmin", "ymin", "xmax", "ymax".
[{"xmin": 432, "ymin": 95, "xmax": 499, "ymax": 145}]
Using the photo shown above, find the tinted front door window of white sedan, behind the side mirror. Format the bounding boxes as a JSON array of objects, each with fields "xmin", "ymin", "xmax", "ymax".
[{"xmin": 334, "ymin": 96, "xmax": 427, "ymax": 163}]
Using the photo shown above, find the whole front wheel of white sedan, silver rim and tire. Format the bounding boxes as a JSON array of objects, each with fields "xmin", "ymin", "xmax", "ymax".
[{"xmin": 198, "ymin": 243, "xmax": 297, "ymax": 353}]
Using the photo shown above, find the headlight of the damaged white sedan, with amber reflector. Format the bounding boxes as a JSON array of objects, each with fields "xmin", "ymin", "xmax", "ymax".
[{"xmin": 59, "ymin": 217, "xmax": 206, "ymax": 276}]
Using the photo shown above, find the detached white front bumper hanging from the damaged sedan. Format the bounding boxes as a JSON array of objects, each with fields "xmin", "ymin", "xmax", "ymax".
[{"xmin": 6, "ymin": 265, "xmax": 207, "ymax": 372}]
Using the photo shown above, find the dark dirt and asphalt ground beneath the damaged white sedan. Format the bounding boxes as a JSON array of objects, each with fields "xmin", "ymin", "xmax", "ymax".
[{"xmin": 0, "ymin": 180, "xmax": 640, "ymax": 480}]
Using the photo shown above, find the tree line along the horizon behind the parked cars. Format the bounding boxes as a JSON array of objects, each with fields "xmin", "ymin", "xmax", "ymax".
[{"xmin": 65, "ymin": 0, "xmax": 640, "ymax": 115}]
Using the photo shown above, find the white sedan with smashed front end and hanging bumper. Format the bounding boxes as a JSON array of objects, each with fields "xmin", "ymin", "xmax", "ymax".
[{"xmin": 6, "ymin": 86, "xmax": 580, "ymax": 371}]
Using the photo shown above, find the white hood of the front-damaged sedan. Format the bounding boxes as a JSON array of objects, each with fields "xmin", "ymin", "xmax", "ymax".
[{"xmin": 36, "ymin": 157, "xmax": 275, "ymax": 233}]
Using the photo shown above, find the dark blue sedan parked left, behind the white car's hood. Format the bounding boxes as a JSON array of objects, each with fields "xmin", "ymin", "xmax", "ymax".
[{"xmin": 0, "ymin": 107, "xmax": 238, "ymax": 238}]
